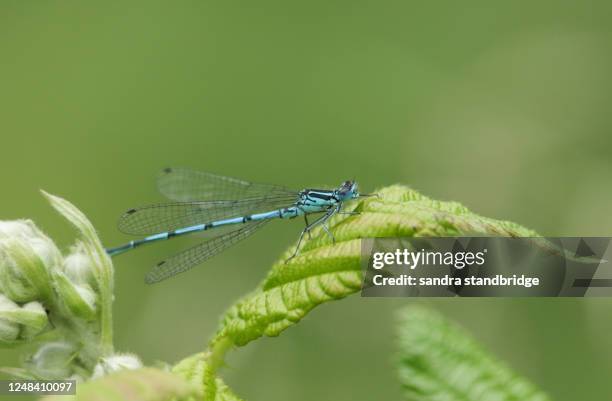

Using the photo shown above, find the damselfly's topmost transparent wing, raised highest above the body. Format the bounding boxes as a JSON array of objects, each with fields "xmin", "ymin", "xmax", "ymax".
[{"xmin": 157, "ymin": 168, "xmax": 296, "ymax": 202}]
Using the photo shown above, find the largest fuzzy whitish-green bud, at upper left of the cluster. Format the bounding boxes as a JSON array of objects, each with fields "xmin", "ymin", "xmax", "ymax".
[{"xmin": 0, "ymin": 220, "xmax": 61, "ymax": 302}]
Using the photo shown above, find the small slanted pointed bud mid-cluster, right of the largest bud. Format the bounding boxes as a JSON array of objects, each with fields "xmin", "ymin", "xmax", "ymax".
[{"xmin": 55, "ymin": 272, "xmax": 96, "ymax": 321}]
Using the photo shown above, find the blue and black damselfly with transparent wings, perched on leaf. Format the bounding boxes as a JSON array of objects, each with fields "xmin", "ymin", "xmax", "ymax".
[{"xmin": 107, "ymin": 168, "xmax": 370, "ymax": 284}]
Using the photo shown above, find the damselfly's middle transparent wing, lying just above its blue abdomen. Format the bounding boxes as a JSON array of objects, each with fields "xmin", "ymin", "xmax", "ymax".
[{"xmin": 118, "ymin": 193, "xmax": 297, "ymax": 235}]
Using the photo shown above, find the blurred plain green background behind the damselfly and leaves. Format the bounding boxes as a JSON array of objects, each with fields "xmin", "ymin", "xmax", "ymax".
[{"xmin": 0, "ymin": 0, "xmax": 612, "ymax": 401}]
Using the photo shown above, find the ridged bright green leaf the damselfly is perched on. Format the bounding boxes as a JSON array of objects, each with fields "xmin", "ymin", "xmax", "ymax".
[{"xmin": 212, "ymin": 185, "xmax": 537, "ymax": 346}]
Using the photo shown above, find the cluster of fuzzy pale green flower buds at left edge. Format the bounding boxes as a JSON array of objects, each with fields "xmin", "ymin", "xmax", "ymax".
[{"xmin": 0, "ymin": 193, "xmax": 142, "ymax": 380}]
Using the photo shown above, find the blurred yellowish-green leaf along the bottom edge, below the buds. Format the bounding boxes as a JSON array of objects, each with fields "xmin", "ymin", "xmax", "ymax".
[{"xmin": 43, "ymin": 368, "xmax": 197, "ymax": 401}]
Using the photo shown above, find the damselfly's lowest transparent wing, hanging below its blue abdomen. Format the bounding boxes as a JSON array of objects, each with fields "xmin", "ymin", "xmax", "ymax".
[{"xmin": 145, "ymin": 220, "xmax": 269, "ymax": 284}]
